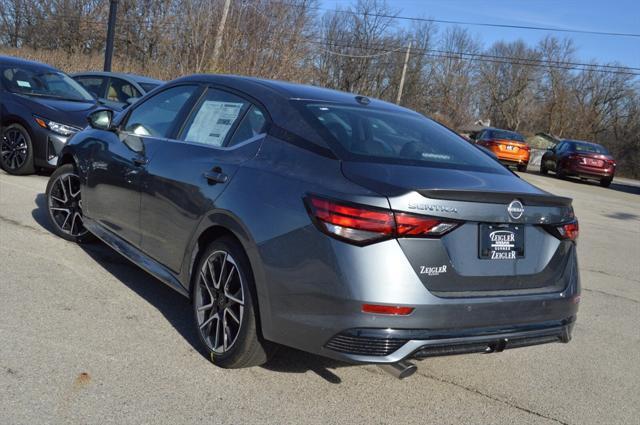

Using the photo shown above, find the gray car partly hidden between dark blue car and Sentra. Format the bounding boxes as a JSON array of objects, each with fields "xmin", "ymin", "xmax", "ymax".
[{"xmin": 71, "ymin": 72, "xmax": 164, "ymax": 111}]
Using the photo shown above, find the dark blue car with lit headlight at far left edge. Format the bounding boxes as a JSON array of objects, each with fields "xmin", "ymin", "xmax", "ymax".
[{"xmin": 0, "ymin": 56, "xmax": 98, "ymax": 174}]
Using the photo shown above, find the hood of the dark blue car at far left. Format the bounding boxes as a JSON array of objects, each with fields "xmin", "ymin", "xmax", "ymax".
[{"xmin": 17, "ymin": 95, "xmax": 98, "ymax": 128}]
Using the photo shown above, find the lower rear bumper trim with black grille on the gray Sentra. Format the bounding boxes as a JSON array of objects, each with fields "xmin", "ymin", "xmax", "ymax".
[{"xmin": 322, "ymin": 316, "xmax": 575, "ymax": 363}]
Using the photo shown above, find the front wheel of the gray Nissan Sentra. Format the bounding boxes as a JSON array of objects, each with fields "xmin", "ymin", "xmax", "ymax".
[{"xmin": 45, "ymin": 164, "xmax": 95, "ymax": 243}]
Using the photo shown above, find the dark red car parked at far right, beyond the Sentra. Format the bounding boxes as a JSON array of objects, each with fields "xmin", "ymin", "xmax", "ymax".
[{"xmin": 540, "ymin": 140, "xmax": 616, "ymax": 187}]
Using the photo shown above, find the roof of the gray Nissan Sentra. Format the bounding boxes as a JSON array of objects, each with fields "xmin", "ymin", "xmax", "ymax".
[{"xmin": 173, "ymin": 74, "xmax": 419, "ymax": 115}]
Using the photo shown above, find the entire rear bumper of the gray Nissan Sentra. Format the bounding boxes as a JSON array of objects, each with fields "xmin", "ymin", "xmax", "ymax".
[{"xmin": 262, "ymin": 235, "xmax": 580, "ymax": 363}]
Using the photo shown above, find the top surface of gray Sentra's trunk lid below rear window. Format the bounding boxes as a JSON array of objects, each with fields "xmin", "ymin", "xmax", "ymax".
[{"xmin": 342, "ymin": 161, "xmax": 546, "ymax": 196}]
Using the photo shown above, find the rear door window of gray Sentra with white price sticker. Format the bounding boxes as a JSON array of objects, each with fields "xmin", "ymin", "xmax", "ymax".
[{"xmin": 182, "ymin": 89, "xmax": 251, "ymax": 147}]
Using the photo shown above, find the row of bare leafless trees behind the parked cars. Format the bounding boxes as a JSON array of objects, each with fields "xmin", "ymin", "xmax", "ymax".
[{"xmin": 0, "ymin": 0, "xmax": 640, "ymax": 177}]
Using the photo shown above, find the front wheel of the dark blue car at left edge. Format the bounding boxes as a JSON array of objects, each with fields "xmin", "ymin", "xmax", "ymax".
[{"xmin": 0, "ymin": 124, "xmax": 35, "ymax": 176}]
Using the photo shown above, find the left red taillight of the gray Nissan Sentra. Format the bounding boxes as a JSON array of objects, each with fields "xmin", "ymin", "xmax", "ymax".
[{"xmin": 305, "ymin": 196, "xmax": 459, "ymax": 245}]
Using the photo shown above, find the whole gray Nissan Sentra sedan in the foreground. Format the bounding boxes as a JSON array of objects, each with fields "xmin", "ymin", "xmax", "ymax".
[{"xmin": 47, "ymin": 75, "xmax": 580, "ymax": 376}]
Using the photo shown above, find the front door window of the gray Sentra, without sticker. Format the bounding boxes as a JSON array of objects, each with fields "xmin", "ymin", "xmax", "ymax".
[{"xmin": 124, "ymin": 86, "xmax": 198, "ymax": 137}]
